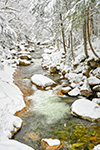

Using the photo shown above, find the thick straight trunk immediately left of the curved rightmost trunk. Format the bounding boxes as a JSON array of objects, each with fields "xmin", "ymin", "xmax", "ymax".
[{"xmin": 83, "ymin": 13, "xmax": 89, "ymax": 58}]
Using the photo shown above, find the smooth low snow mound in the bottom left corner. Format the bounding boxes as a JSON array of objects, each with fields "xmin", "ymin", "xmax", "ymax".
[{"xmin": 0, "ymin": 140, "xmax": 34, "ymax": 150}]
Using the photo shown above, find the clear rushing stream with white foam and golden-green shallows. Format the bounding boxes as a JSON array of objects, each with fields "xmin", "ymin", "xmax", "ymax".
[{"xmin": 13, "ymin": 46, "xmax": 100, "ymax": 150}]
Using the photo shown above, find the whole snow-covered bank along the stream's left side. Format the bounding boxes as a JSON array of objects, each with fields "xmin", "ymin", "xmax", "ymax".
[{"xmin": 0, "ymin": 63, "xmax": 32, "ymax": 150}]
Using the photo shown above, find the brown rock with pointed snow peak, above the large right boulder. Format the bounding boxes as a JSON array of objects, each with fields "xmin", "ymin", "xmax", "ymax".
[{"xmin": 80, "ymin": 78, "xmax": 93, "ymax": 97}]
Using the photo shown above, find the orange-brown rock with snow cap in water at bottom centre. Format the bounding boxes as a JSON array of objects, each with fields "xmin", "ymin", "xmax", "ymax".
[{"xmin": 41, "ymin": 138, "xmax": 63, "ymax": 150}]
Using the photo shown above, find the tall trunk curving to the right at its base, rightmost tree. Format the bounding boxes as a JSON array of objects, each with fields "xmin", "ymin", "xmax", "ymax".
[{"xmin": 87, "ymin": 8, "xmax": 99, "ymax": 58}]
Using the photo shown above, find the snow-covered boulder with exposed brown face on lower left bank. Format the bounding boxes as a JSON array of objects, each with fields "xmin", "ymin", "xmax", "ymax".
[{"xmin": 0, "ymin": 109, "xmax": 22, "ymax": 140}]
